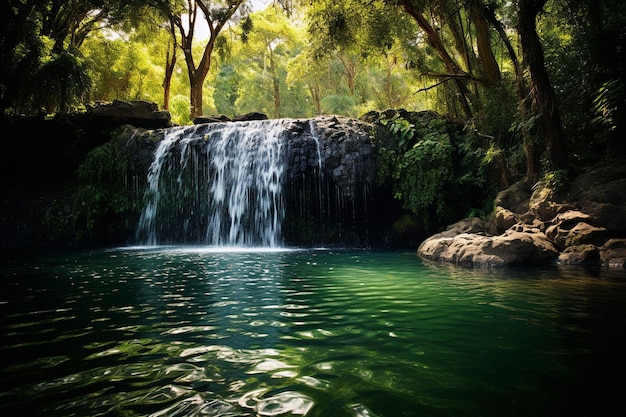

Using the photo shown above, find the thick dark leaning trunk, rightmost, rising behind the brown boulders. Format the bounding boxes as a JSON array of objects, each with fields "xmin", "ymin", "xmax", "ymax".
[{"xmin": 518, "ymin": 0, "xmax": 569, "ymax": 170}]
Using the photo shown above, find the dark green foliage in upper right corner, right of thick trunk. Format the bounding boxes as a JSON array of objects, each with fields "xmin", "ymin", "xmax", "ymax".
[{"xmin": 538, "ymin": 0, "xmax": 626, "ymax": 159}]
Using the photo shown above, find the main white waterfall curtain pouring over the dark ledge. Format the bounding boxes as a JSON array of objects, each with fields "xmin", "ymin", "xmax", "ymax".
[{"xmin": 136, "ymin": 120, "xmax": 288, "ymax": 247}]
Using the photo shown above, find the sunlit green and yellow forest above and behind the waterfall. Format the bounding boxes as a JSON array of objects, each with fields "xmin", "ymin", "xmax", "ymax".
[{"xmin": 0, "ymin": 0, "xmax": 626, "ymax": 245}]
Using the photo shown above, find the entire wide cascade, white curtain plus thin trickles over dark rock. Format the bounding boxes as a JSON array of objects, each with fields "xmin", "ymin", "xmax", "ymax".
[{"xmin": 134, "ymin": 117, "xmax": 378, "ymax": 247}]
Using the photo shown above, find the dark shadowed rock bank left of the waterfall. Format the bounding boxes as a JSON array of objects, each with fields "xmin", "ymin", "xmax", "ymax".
[{"xmin": 0, "ymin": 101, "xmax": 171, "ymax": 247}]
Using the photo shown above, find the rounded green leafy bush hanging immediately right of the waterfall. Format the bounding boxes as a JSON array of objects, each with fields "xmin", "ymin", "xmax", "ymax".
[{"xmin": 378, "ymin": 115, "xmax": 485, "ymax": 228}]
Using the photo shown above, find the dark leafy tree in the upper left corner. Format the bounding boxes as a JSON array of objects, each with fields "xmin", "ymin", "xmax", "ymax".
[{"xmin": 0, "ymin": 0, "xmax": 151, "ymax": 113}]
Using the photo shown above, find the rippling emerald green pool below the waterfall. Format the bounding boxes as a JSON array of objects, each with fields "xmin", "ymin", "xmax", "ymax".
[{"xmin": 0, "ymin": 247, "xmax": 626, "ymax": 417}]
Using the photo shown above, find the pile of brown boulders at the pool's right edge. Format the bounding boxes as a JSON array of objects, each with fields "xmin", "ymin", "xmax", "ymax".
[{"xmin": 418, "ymin": 159, "xmax": 626, "ymax": 268}]
